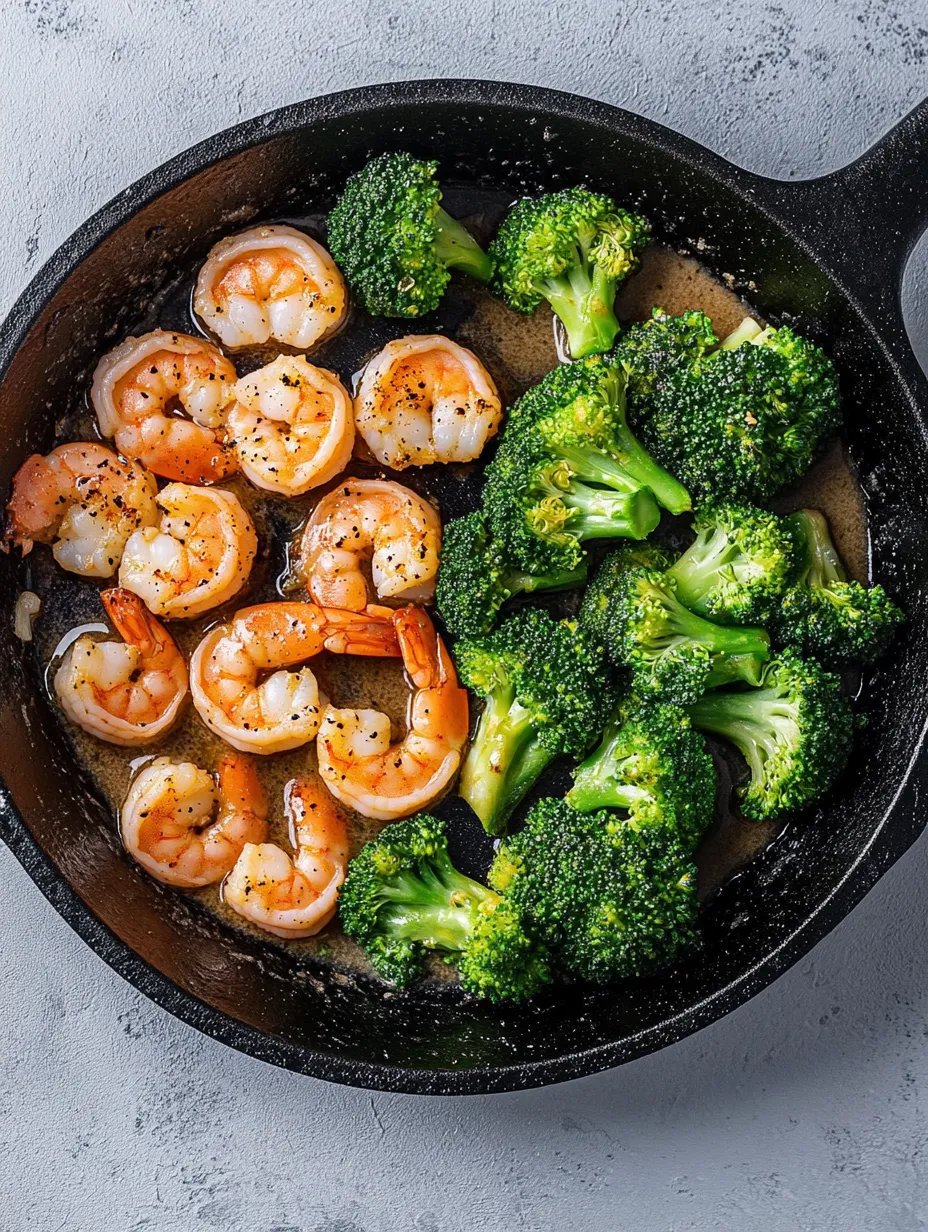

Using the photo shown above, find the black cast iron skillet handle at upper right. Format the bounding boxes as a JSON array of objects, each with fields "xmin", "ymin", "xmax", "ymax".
[{"xmin": 760, "ymin": 99, "xmax": 928, "ymax": 304}]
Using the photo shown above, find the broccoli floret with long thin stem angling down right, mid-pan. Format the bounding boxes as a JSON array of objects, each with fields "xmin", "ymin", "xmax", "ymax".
[{"xmin": 507, "ymin": 355, "xmax": 691, "ymax": 514}]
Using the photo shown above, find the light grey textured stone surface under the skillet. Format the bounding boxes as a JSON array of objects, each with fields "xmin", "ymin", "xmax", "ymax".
[{"xmin": 0, "ymin": 0, "xmax": 928, "ymax": 1232}]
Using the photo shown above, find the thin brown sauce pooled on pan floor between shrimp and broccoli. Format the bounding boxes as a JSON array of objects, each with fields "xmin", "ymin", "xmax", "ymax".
[{"xmin": 30, "ymin": 211, "xmax": 868, "ymax": 976}]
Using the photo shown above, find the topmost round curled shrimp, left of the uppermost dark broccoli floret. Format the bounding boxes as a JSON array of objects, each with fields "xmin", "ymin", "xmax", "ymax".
[{"xmin": 193, "ymin": 227, "xmax": 348, "ymax": 351}]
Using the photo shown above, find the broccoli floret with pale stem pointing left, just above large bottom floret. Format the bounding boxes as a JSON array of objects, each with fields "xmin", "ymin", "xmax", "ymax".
[{"xmin": 567, "ymin": 699, "xmax": 715, "ymax": 851}]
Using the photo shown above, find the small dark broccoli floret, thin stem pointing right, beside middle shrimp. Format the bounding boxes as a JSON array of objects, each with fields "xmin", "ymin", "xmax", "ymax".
[{"xmin": 435, "ymin": 513, "xmax": 587, "ymax": 637}]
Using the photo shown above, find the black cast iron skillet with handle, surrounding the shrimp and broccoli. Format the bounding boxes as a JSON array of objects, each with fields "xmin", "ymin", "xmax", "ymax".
[{"xmin": 0, "ymin": 81, "xmax": 928, "ymax": 1094}]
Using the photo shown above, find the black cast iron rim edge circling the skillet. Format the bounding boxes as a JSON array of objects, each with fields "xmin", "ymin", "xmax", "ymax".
[{"xmin": 0, "ymin": 79, "xmax": 924, "ymax": 1095}]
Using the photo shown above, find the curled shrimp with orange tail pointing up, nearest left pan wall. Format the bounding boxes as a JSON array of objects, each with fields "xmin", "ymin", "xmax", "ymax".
[{"xmin": 54, "ymin": 589, "xmax": 187, "ymax": 745}]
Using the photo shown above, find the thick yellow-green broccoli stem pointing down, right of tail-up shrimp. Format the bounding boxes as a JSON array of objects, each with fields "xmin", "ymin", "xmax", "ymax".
[{"xmin": 458, "ymin": 690, "xmax": 553, "ymax": 835}]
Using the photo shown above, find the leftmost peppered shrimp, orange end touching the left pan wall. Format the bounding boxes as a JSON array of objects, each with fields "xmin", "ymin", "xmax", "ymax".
[{"xmin": 4, "ymin": 442, "xmax": 158, "ymax": 578}]
